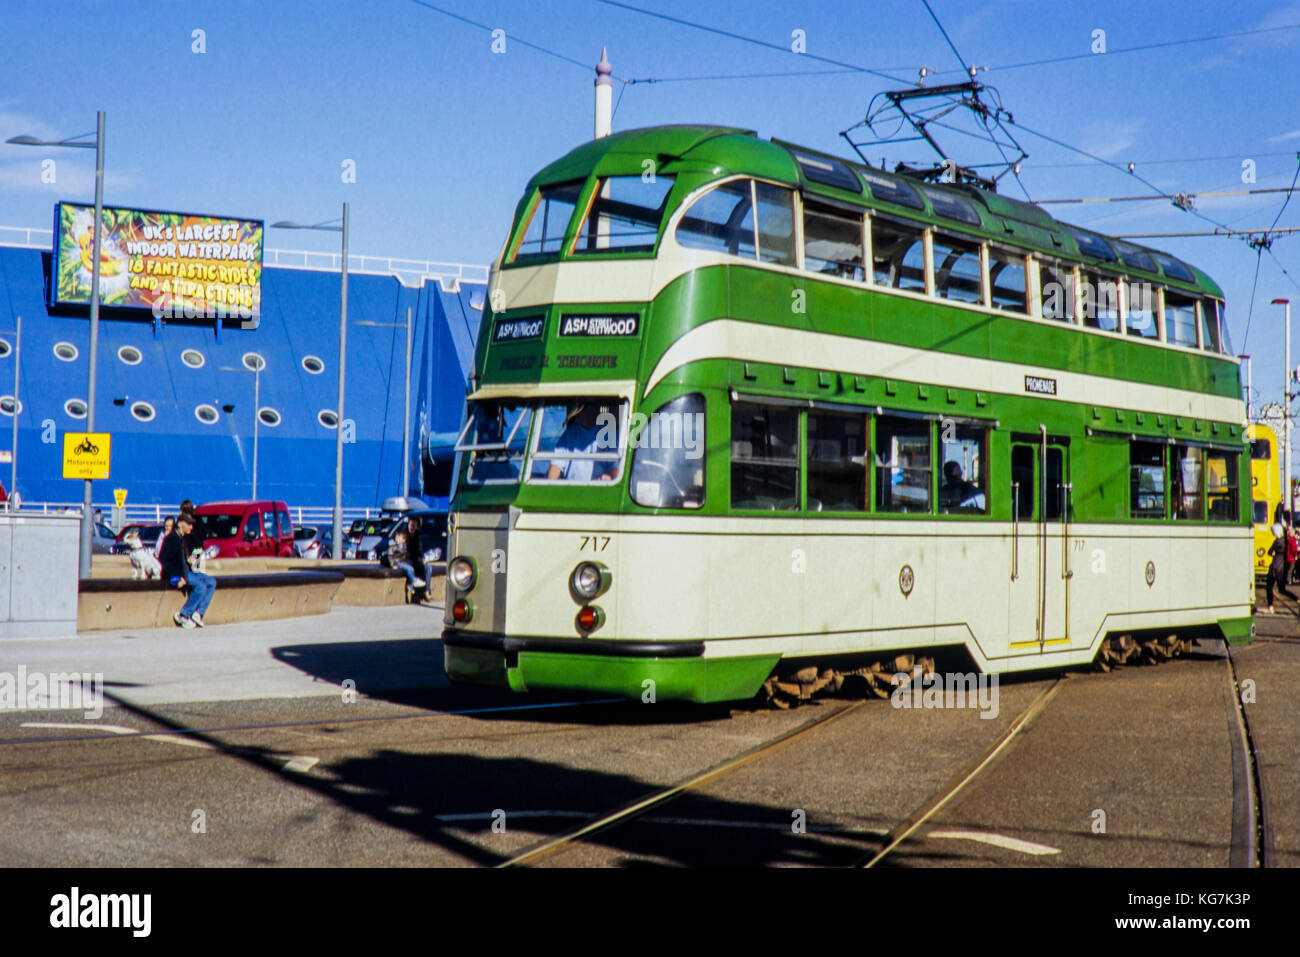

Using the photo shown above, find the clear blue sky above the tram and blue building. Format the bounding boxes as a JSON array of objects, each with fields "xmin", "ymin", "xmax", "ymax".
[{"xmin": 0, "ymin": 0, "xmax": 1300, "ymax": 399}]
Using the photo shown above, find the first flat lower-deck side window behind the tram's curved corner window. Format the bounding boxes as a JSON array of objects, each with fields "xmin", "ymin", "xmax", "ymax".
[{"xmin": 731, "ymin": 402, "xmax": 800, "ymax": 511}]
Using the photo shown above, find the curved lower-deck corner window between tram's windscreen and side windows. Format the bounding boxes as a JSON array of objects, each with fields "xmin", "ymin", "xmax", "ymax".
[{"xmin": 629, "ymin": 393, "xmax": 705, "ymax": 508}]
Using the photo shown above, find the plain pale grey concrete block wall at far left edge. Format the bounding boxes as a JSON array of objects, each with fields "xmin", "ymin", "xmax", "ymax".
[{"xmin": 0, "ymin": 512, "xmax": 81, "ymax": 638}]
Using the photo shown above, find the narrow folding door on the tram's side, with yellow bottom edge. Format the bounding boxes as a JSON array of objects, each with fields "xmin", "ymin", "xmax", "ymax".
[{"xmin": 1008, "ymin": 429, "xmax": 1073, "ymax": 653}]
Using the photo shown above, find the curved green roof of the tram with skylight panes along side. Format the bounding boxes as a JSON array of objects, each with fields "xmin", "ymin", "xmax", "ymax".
[{"xmin": 529, "ymin": 125, "xmax": 1223, "ymax": 298}]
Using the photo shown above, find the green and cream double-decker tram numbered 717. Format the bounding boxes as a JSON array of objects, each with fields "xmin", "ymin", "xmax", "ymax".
[{"xmin": 443, "ymin": 126, "xmax": 1253, "ymax": 701}]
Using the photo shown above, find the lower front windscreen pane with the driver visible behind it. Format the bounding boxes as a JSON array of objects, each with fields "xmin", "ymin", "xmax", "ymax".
[{"xmin": 528, "ymin": 398, "xmax": 628, "ymax": 485}]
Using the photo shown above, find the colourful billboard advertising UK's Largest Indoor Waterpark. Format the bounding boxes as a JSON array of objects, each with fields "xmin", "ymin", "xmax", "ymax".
[{"xmin": 49, "ymin": 203, "xmax": 265, "ymax": 321}]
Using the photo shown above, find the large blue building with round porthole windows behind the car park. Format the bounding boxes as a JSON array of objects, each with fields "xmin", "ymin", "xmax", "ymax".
[{"xmin": 0, "ymin": 230, "xmax": 486, "ymax": 512}]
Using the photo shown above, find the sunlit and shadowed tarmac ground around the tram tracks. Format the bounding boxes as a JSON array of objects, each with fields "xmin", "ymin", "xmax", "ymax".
[{"xmin": 0, "ymin": 603, "xmax": 1300, "ymax": 867}]
